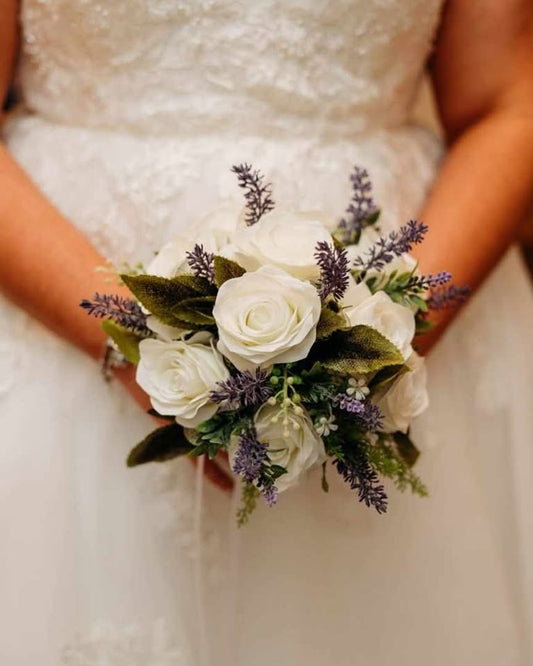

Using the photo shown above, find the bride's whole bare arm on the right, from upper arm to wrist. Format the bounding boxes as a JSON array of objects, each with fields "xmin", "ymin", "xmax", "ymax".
[{"xmin": 417, "ymin": 0, "xmax": 533, "ymax": 349}]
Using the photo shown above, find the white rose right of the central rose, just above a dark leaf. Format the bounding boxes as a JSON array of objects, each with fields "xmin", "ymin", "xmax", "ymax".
[{"xmin": 344, "ymin": 291, "xmax": 415, "ymax": 359}]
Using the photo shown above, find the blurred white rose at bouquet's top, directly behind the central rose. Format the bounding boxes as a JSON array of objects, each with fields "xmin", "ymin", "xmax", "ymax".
[{"xmin": 225, "ymin": 210, "xmax": 331, "ymax": 281}]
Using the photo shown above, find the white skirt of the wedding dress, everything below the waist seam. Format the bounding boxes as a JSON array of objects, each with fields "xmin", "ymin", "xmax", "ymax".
[{"xmin": 0, "ymin": 116, "xmax": 533, "ymax": 666}]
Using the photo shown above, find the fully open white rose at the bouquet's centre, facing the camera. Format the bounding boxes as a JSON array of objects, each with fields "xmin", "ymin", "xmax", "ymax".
[{"xmin": 213, "ymin": 266, "xmax": 320, "ymax": 370}]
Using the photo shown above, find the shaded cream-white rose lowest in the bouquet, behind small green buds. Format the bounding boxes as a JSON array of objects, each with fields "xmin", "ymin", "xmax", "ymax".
[{"xmin": 230, "ymin": 405, "xmax": 326, "ymax": 492}]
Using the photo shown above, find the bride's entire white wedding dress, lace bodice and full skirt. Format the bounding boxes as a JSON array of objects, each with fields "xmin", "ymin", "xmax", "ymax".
[{"xmin": 0, "ymin": 0, "xmax": 533, "ymax": 666}]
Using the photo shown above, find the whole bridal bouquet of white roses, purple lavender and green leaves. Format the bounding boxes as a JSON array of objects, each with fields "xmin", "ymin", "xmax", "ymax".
[{"xmin": 81, "ymin": 164, "xmax": 465, "ymax": 524}]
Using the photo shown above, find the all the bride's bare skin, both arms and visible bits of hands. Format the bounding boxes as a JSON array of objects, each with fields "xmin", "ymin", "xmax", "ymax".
[{"xmin": 0, "ymin": 0, "xmax": 533, "ymax": 480}]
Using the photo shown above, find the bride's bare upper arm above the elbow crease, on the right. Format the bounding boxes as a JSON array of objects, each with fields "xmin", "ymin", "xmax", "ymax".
[{"xmin": 432, "ymin": 0, "xmax": 533, "ymax": 137}]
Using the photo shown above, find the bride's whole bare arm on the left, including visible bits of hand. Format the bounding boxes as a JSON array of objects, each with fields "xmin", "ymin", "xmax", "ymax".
[{"xmin": 0, "ymin": 0, "xmax": 231, "ymax": 488}]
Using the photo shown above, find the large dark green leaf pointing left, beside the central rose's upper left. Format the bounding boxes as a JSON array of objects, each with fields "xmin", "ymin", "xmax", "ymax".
[{"xmin": 121, "ymin": 275, "xmax": 216, "ymax": 329}]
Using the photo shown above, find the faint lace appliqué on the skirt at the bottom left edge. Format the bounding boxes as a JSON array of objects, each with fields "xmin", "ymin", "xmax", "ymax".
[{"xmin": 61, "ymin": 620, "xmax": 190, "ymax": 666}]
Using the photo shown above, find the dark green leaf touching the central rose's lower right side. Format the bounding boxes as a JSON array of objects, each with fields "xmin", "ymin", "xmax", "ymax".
[{"xmin": 312, "ymin": 325, "xmax": 403, "ymax": 375}]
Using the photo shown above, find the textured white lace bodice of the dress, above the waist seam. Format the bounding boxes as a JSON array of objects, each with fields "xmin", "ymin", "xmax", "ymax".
[{"xmin": 20, "ymin": 0, "xmax": 441, "ymax": 138}]
